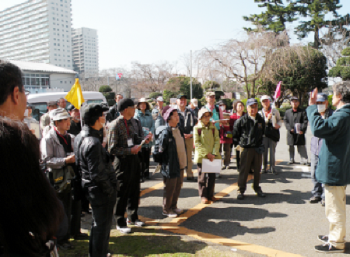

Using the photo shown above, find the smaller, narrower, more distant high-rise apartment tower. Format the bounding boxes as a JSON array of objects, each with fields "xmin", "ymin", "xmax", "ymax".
[{"xmin": 72, "ymin": 28, "xmax": 98, "ymax": 77}]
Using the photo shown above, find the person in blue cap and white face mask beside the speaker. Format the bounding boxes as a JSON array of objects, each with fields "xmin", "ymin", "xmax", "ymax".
[{"xmin": 310, "ymin": 93, "xmax": 333, "ymax": 206}]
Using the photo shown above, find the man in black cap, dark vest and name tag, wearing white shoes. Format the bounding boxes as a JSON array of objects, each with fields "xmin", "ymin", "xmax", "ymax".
[{"xmin": 108, "ymin": 98, "xmax": 152, "ymax": 233}]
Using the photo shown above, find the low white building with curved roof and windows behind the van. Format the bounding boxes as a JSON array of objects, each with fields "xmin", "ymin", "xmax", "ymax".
[{"xmin": 9, "ymin": 60, "xmax": 76, "ymax": 93}]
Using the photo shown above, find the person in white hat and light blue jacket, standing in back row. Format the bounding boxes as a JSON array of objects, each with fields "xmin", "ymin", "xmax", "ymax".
[{"xmin": 134, "ymin": 98, "xmax": 155, "ymax": 182}]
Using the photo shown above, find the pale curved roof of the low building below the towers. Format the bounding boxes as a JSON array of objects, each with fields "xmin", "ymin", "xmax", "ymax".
[{"xmin": 8, "ymin": 60, "xmax": 76, "ymax": 74}]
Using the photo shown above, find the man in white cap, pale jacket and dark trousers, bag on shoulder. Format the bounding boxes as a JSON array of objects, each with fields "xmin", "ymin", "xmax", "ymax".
[{"xmin": 259, "ymin": 95, "xmax": 282, "ymax": 175}]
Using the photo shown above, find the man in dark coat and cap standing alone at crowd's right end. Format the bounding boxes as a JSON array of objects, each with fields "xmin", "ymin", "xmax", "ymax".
[{"xmin": 284, "ymin": 97, "xmax": 308, "ymax": 165}]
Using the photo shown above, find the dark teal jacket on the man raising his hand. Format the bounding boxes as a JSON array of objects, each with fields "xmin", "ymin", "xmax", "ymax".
[{"xmin": 306, "ymin": 104, "xmax": 350, "ymax": 186}]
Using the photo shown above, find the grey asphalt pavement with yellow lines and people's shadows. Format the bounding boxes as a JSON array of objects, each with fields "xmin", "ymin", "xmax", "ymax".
[{"xmin": 84, "ymin": 121, "xmax": 350, "ymax": 254}]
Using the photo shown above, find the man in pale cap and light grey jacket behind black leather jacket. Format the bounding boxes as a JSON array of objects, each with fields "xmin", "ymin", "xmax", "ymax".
[{"xmin": 40, "ymin": 108, "xmax": 75, "ymax": 249}]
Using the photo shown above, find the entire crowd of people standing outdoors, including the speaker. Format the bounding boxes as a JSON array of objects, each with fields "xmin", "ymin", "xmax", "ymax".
[{"xmin": 0, "ymin": 61, "xmax": 350, "ymax": 254}]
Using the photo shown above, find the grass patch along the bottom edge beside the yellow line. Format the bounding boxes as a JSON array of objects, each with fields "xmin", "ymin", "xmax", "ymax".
[{"xmin": 59, "ymin": 228, "xmax": 243, "ymax": 257}]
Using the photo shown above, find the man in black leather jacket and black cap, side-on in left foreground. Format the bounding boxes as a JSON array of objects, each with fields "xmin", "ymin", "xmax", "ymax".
[{"xmin": 74, "ymin": 104, "xmax": 118, "ymax": 256}]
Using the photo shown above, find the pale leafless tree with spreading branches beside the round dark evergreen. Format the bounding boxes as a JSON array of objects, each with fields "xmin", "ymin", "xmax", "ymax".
[{"xmin": 202, "ymin": 31, "xmax": 289, "ymax": 98}]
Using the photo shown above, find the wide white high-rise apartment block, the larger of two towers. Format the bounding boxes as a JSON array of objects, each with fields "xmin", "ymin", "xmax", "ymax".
[{"xmin": 0, "ymin": 0, "xmax": 73, "ymax": 69}]
